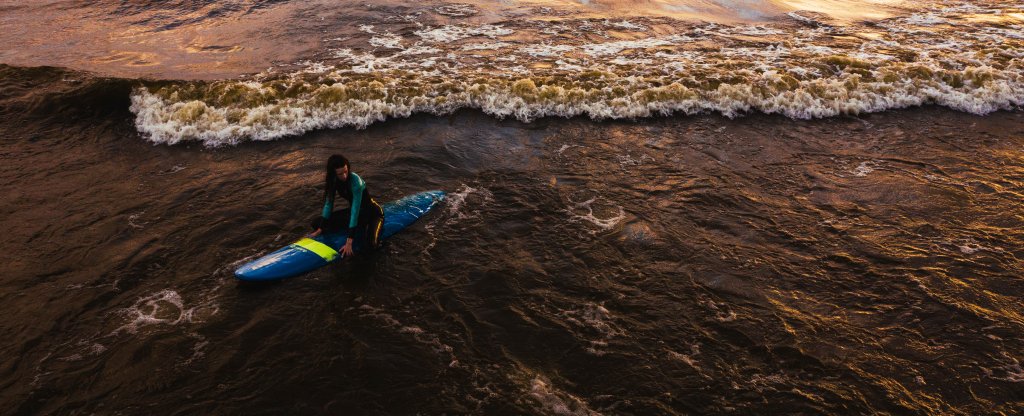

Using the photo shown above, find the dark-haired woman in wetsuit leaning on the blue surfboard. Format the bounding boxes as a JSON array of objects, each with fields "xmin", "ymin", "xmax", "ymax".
[{"xmin": 309, "ymin": 155, "xmax": 384, "ymax": 256}]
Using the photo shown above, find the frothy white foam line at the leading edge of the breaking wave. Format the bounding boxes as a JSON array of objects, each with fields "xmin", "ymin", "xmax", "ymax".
[{"xmin": 131, "ymin": 67, "xmax": 1024, "ymax": 147}]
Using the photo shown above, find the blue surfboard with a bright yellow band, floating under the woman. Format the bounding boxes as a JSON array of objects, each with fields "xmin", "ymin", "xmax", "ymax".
[{"xmin": 234, "ymin": 191, "xmax": 444, "ymax": 282}]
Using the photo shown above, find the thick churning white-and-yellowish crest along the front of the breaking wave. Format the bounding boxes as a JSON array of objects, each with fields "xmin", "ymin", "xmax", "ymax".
[{"xmin": 131, "ymin": 59, "xmax": 1024, "ymax": 147}]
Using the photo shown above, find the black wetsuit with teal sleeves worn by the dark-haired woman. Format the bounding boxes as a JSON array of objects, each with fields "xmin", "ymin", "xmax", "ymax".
[{"xmin": 312, "ymin": 172, "xmax": 384, "ymax": 249}]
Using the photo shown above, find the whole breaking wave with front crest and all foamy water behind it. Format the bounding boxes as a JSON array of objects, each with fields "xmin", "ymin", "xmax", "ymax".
[{"xmin": 123, "ymin": 1, "xmax": 1024, "ymax": 147}]
